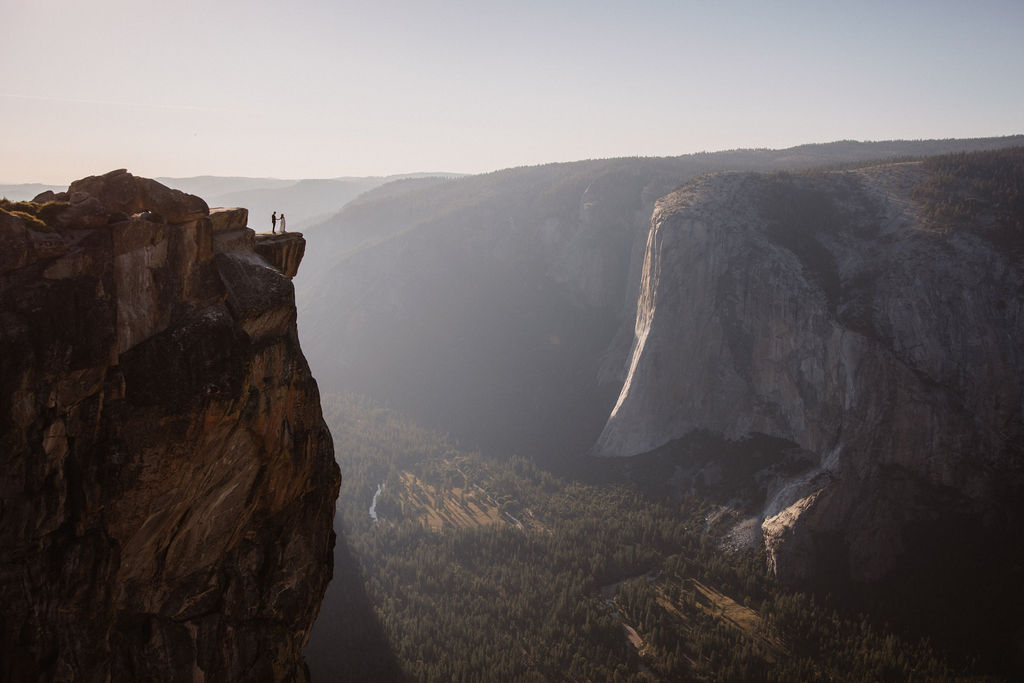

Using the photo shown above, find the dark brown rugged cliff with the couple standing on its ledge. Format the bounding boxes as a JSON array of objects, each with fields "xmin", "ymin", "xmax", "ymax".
[{"xmin": 0, "ymin": 171, "xmax": 340, "ymax": 681}]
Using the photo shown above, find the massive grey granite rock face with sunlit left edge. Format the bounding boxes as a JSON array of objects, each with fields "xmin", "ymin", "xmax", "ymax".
[{"xmin": 597, "ymin": 165, "xmax": 1024, "ymax": 580}]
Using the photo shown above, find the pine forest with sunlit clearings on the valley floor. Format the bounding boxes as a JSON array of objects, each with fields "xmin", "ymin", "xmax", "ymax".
[{"xmin": 313, "ymin": 395, "xmax": 982, "ymax": 681}]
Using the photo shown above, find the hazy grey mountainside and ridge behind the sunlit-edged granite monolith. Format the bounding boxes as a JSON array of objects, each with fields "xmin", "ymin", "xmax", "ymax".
[{"xmin": 299, "ymin": 137, "xmax": 1024, "ymax": 462}]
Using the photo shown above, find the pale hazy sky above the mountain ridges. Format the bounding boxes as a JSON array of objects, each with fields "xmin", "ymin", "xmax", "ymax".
[{"xmin": 0, "ymin": 0, "xmax": 1024, "ymax": 184}]
